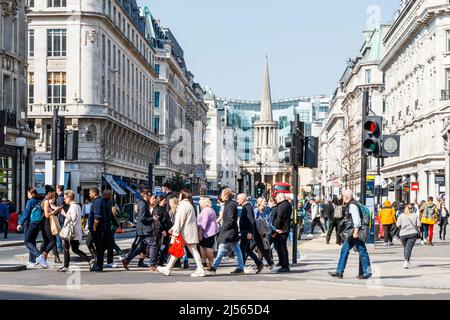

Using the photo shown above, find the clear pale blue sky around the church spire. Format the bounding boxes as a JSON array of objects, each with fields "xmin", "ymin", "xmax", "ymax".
[{"xmin": 138, "ymin": 0, "xmax": 399, "ymax": 99}]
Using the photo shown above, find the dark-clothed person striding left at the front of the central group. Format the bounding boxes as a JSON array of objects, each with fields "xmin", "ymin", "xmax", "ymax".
[{"xmin": 122, "ymin": 189, "xmax": 157, "ymax": 271}]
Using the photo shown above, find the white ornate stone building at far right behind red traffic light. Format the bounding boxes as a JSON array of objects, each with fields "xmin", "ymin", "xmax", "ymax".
[{"xmin": 380, "ymin": 0, "xmax": 450, "ymax": 201}]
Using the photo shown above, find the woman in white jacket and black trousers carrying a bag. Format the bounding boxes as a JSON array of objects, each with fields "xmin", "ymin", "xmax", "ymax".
[{"xmin": 58, "ymin": 190, "xmax": 89, "ymax": 272}]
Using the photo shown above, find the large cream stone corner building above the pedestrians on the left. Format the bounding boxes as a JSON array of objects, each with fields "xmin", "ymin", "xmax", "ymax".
[{"xmin": 28, "ymin": 0, "xmax": 159, "ymax": 203}]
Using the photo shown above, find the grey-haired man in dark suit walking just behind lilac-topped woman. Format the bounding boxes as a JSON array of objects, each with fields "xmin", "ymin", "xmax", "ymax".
[{"xmin": 237, "ymin": 193, "xmax": 264, "ymax": 273}]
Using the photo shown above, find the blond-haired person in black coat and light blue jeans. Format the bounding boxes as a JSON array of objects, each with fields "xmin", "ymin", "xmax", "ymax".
[{"xmin": 207, "ymin": 188, "xmax": 244, "ymax": 275}]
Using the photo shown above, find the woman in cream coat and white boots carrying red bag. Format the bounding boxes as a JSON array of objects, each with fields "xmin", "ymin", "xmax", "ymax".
[{"xmin": 158, "ymin": 189, "xmax": 205, "ymax": 277}]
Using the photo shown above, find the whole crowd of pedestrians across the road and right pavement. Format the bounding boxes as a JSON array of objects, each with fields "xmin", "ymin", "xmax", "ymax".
[{"xmin": 12, "ymin": 184, "xmax": 449, "ymax": 279}]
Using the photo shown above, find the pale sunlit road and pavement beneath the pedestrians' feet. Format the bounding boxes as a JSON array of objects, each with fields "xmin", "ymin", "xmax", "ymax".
[{"xmin": 0, "ymin": 226, "xmax": 450, "ymax": 300}]
